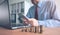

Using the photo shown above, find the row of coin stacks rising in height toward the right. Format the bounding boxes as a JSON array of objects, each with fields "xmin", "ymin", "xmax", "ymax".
[{"xmin": 21, "ymin": 25, "xmax": 43, "ymax": 33}]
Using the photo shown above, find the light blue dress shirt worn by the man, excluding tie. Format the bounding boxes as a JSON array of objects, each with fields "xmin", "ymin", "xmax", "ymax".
[{"xmin": 27, "ymin": 0, "xmax": 60, "ymax": 27}]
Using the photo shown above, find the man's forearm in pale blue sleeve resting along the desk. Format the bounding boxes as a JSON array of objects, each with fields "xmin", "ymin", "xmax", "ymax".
[{"xmin": 38, "ymin": 20, "xmax": 60, "ymax": 27}]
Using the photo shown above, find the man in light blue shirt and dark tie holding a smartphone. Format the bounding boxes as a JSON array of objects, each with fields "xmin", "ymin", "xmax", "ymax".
[{"xmin": 24, "ymin": 0, "xmax": 60, "ymax": 27}]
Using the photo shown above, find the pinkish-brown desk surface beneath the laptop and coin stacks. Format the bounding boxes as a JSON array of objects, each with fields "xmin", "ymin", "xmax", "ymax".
[{"xmin": 0, "ymin": 27, "xmax": 60, "ymax": 35}]
